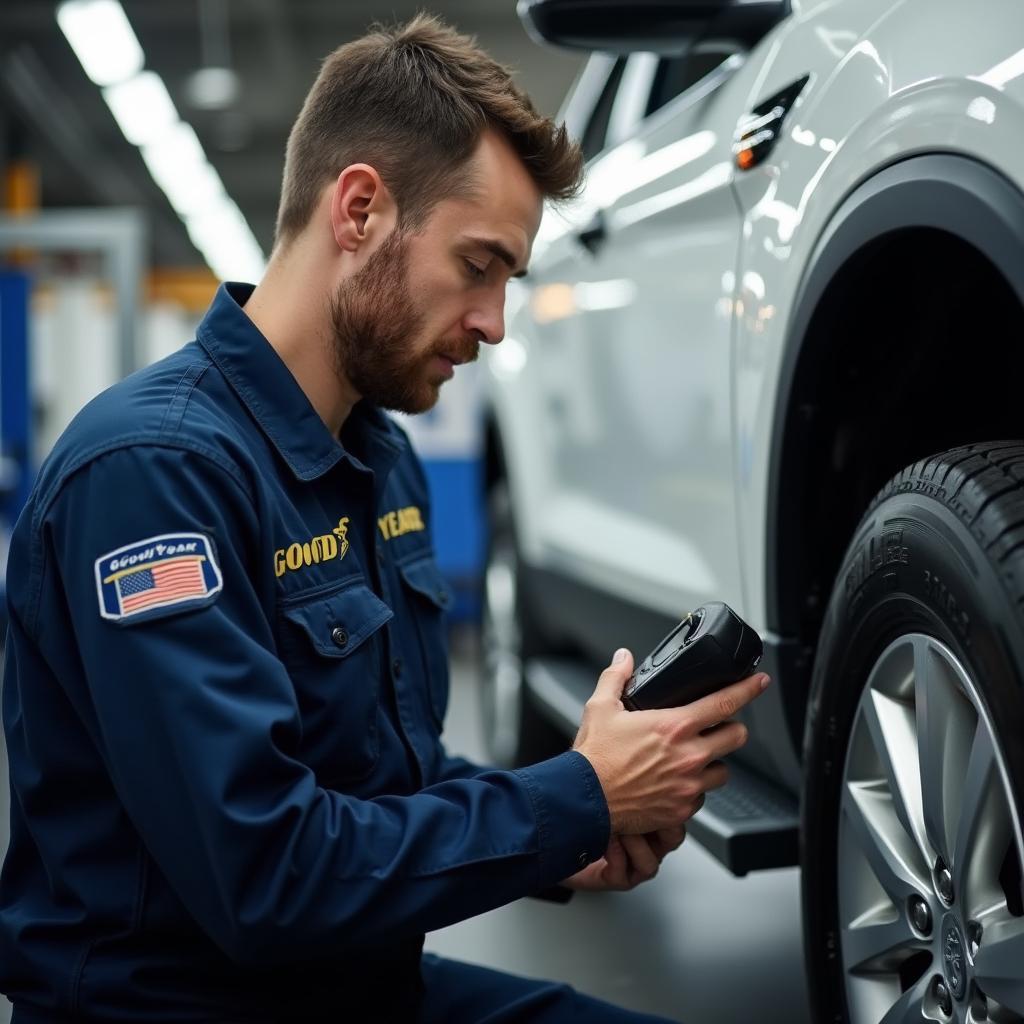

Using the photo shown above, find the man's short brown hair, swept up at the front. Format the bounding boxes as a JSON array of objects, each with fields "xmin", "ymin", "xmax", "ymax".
[{"xmin": 276, "ymin": 14, "xmax": 583, "ymax": 244}]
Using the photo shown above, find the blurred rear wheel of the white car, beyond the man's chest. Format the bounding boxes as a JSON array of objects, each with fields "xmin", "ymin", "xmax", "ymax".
[{"xmin": 480, "ymin": 479, "xmax": 568, "ymax": 768}]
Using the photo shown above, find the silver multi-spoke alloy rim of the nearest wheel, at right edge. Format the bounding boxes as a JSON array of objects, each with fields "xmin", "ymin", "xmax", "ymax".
[{"xmin": 838, "ymin": 633, "xmax": 1024, "ymax": 1024}]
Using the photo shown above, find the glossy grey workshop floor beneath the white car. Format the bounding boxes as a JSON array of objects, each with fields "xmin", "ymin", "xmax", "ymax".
[{"xmin": 0, "ymin": 637, "xmax": 810, "ymax": 1024}]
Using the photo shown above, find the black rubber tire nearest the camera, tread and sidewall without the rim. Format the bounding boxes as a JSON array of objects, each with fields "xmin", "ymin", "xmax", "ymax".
[{"xmin": 801, "ymin": 441, "xmax": 1024, "ymax": 1024}]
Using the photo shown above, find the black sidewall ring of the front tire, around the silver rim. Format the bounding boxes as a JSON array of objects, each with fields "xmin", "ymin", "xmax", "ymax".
[{"xmin": 801, "ymin": 478, "xmax": 1024, "ymax": 1024}]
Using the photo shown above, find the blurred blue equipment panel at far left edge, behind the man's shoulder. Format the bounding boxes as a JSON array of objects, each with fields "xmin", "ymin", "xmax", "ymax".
[{"xmin": 0, "ymin": 270, "xmax": 32, "ymax": 643}]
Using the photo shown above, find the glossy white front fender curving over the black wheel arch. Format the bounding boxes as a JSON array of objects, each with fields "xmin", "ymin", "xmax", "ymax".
[{"xmin": 734, "ymin": 0, "xmax": 1024, "ymax": 631}]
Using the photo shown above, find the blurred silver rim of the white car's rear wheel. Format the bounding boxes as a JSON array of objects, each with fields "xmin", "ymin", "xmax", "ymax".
[{"xmin": 481, "ymin": 535, "xmax": 522, "ymax": 765}]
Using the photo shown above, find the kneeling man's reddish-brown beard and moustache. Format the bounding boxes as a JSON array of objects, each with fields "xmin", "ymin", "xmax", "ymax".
[{"xmin": 331, "ymin": 229, "xmax": 478, "ymax": 413}]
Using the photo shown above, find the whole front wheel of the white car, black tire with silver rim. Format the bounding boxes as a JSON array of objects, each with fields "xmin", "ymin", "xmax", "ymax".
[{"xmin": 802, "ymin": 442, "xmax": 1024, "ymax": 1024}]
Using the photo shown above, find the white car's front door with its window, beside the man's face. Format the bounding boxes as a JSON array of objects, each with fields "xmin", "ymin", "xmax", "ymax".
[{"xmin": 529, "ymin": 49, "xmax": 745, "ymax": 617}]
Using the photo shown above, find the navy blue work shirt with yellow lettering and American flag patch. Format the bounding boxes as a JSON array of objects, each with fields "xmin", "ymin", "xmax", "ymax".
[{"xmin": 0, "ymin": 285, "xmax": 609, "ymax": 1024}]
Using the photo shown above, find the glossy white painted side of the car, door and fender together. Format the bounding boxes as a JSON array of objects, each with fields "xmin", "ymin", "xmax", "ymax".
[{"xmin": 487, "ymin": 0, "xmax": 1024, "ymax": 790}]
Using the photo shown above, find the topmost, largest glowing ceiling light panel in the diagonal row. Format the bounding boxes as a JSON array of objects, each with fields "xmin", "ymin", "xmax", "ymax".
[{"xmin": 57, "ymin": 0, "xmax": 144, "ymax": 86}]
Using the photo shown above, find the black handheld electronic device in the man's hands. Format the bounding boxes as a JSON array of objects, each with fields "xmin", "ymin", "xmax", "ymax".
[{"xmin": 623, "ymin": 601, "xmax": 764, "ymax": 711}]
